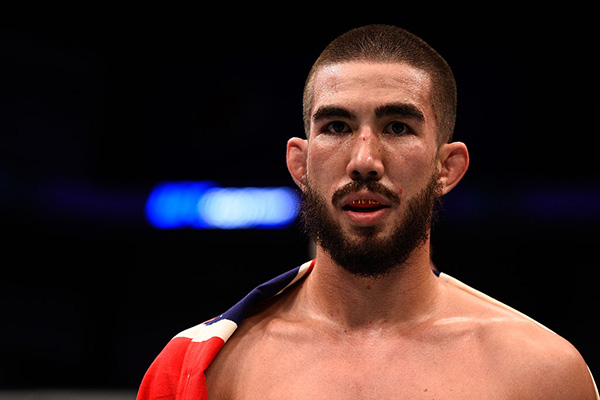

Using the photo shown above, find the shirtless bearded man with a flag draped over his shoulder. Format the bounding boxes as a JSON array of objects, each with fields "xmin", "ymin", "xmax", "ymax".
[{"xmin": 139, "ymin": 25, "xmax": 598, "ymax": 400}]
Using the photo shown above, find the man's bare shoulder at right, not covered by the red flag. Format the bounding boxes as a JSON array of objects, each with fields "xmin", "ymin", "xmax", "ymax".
[{"xmin": 441, "ymin": 275, "xmax": 597, "ymax": 399}]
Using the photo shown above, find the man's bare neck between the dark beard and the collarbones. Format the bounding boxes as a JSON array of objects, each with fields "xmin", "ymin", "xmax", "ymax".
[{"xmin": 304, "ymin": 242, "xmax": 440, "ymax": 330}]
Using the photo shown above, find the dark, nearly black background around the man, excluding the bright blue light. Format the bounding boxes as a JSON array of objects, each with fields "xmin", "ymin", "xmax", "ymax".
[{"xmin": 0, "ymin": 6, "xmax": 600, "ymax": 388}]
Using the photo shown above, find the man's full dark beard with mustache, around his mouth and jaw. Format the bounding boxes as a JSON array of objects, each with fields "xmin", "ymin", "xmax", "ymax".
[{"xmin": 300, "ymin": 175, "xmax": 442, "ymax": 278}]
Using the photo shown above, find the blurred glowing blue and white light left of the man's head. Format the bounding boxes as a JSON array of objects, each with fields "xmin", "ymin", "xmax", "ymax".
[{"xmin": 145, "ymin": 181, "xmax": 299, "ymax": 229}]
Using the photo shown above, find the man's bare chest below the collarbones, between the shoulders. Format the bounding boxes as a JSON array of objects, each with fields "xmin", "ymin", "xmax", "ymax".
[{"xmin": 207, "ymin": 330, "xmax": 506, "ymax": 400}]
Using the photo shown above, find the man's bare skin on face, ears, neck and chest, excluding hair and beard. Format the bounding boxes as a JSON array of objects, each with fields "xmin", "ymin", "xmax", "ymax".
[{"xmin": 206, "ymin": 62, "xmax": 596, "ymax": 400}]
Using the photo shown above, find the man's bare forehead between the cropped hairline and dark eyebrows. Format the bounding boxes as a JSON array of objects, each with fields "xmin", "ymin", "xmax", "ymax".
[{"xmin": 311, "ymin": 62, "xmax": 432, "ymax": 117}]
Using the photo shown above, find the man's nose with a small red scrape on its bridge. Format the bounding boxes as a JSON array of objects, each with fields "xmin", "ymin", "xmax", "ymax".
[{"xmin": 346, "ymin": 132, "xmax": 384, "ymax": 180}]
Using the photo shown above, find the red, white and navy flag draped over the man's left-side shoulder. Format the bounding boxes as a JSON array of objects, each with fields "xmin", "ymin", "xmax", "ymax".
[{"xmin": 137, "ymin": 260, "xmax": 315, "ymax": 400}]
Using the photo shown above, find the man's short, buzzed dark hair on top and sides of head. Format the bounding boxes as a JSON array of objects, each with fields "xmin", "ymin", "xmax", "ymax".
[{"xmin": 303, "ymin": 25, "xmax": 456, "ymax": 143}]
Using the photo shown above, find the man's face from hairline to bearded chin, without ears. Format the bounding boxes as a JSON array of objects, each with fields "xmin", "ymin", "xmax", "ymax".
[{"xmin": 304, "ymin": 62, "xmax": 439, "ymax": 275}]
